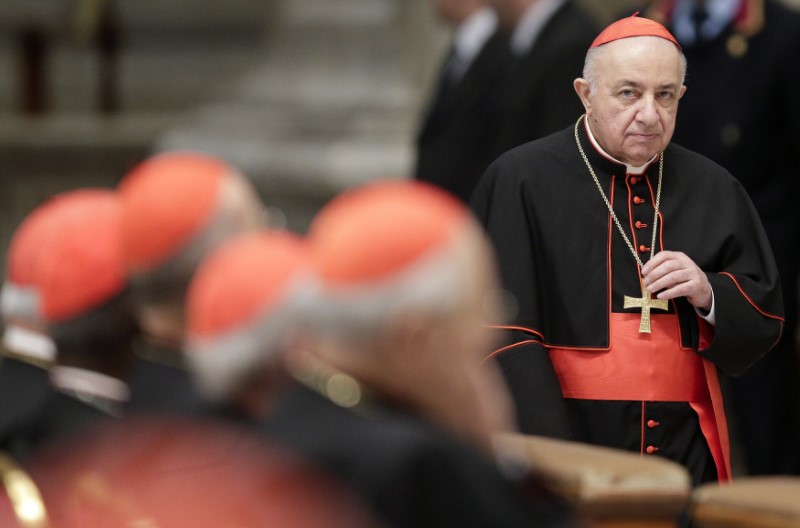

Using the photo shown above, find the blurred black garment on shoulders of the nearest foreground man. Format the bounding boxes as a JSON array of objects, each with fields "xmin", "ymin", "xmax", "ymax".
[{"xmin": 267, "ymin": 386, "xmax": 572, "ymax": 528}]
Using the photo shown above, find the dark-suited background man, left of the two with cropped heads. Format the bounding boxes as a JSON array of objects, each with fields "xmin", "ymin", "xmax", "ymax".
[{"xmin": 415, "ymin": 0, "xmax": 511, "ymax": 202}]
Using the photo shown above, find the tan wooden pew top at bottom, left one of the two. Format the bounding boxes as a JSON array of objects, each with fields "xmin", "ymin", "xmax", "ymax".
[{"xmin": 495, "ymin": 434, "xmax": 691, "ymax": 528}]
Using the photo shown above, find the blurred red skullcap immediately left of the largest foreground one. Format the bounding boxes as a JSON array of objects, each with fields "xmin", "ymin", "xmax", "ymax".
[{"xmin": 187, "ymin": 231, "xmax": 307, "ymax": 338}]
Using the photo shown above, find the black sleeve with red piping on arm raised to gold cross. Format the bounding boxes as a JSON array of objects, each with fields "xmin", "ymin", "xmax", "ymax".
[{"xmin": 699, "ymin": 179, "xmax": 783, "ymax": 375}]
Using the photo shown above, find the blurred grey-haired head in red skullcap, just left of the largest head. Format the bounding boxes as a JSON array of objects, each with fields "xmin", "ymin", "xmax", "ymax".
[{"xmin": 186, "ymin": 231, "xmax": 308, "ymax": 418}]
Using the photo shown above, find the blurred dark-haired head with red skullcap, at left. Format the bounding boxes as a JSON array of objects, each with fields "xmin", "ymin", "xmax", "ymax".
[{"xmin": 34, "ymin": 189, "xmax": 137, "ymax": 379}]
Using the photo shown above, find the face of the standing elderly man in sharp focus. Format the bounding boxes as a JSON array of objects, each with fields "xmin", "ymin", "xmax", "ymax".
[{"xmin": 575, "ymin": 37, "xmax": 686, "ymax": 166}]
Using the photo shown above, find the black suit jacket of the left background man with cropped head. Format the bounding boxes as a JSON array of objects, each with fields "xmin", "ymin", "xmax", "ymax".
[{"xmin": 414, "ymin": 32, "xmax": 511, "ymax": 202}]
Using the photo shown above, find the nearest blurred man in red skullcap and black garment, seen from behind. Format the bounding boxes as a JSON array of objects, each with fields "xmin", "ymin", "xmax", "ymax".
[{"xmin": 267, "ymin": 182, "xmax": 570, "ymax": 528}]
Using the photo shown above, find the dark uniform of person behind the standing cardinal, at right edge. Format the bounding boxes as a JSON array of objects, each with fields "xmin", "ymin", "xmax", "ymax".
[{"xmin": 674, "ymin": 0, "xmax": 800, "ymax": 474}]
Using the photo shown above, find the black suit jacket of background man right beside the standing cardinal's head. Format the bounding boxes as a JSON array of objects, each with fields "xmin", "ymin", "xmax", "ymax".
[{"xmin": 494, "ymin": 1, "xmax": 599, "ymax": 155}]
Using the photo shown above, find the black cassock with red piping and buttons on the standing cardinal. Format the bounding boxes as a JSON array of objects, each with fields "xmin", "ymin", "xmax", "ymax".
[{"xmin": 472, "ymin": 119, "xmax": 783, "ymax": 483}]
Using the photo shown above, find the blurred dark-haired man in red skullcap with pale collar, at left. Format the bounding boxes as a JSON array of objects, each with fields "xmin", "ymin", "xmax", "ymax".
[{"xmin": 0, "ymin": 189, "xmax": 136, "ymax": 461}]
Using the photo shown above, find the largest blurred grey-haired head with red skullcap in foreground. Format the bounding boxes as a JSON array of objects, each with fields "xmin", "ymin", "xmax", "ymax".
[{"xmin": 289, "ymin": 181, "xmax": 511, "ymax": 446}]
